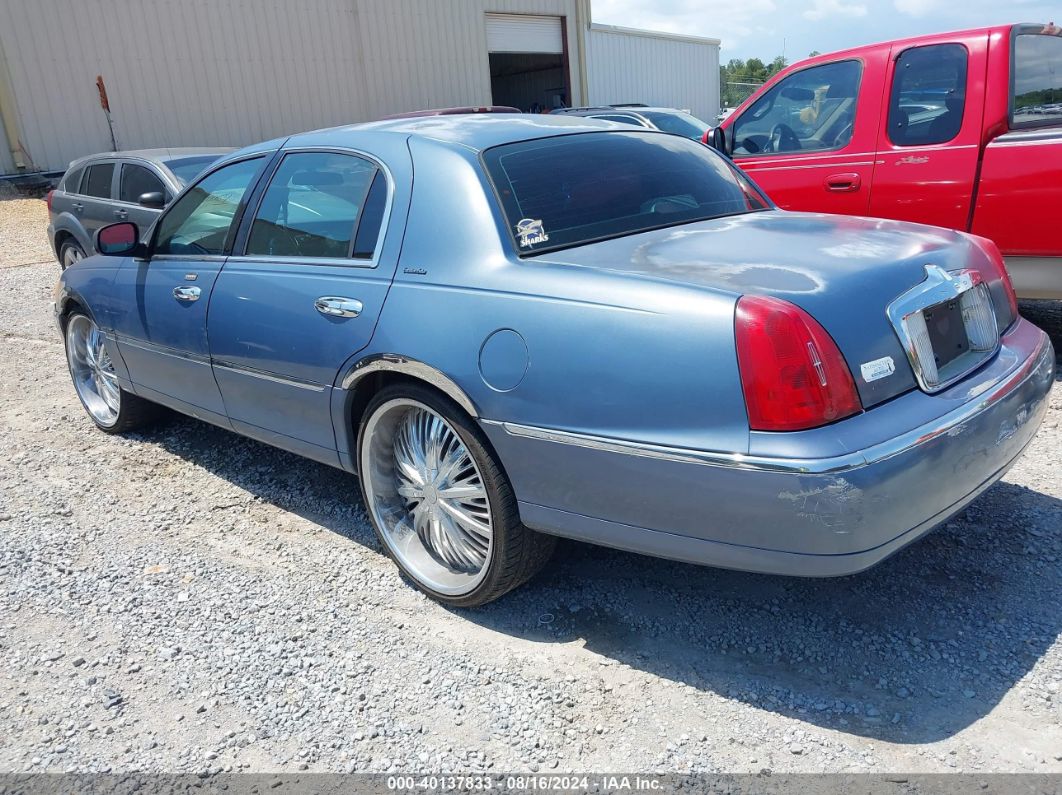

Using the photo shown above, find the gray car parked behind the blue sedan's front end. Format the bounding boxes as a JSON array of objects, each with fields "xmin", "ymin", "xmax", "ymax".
[{"xmin": 48, "ymin": 148, "xmax": 233, "ymax": 270}]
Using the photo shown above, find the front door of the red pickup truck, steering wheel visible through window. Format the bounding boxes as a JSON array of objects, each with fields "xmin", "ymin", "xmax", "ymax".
[{"xmin": 723, "ymin": 48, "xmax": 888, "ymax": 215}]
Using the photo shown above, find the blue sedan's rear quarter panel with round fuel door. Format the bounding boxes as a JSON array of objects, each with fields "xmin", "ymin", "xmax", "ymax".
[{"xmin": 352, "ymin": 139, "xmax": 749, "ymax": 452}]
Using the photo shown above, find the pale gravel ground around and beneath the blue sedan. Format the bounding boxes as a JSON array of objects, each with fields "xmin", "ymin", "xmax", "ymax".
[{"xmin": 0, "ymin": 203, "xmax": 1062, "ymax": 773}]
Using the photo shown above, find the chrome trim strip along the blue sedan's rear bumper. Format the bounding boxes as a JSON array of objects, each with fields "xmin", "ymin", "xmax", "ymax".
[{"xmin": 481, "ymin": 334, "xmax": 1054, "ymax": 474}]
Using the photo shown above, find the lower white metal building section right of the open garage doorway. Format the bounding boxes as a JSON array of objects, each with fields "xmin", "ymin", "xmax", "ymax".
[{"xmin": 586, "ymin": 24, "xmax": 719, "ymax": 124}]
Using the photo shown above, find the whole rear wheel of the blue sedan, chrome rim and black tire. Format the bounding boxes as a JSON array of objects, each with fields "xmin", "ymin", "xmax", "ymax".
[{"xmin": 358, "ymin": 384, "xmax": 555, "ymax": 607}]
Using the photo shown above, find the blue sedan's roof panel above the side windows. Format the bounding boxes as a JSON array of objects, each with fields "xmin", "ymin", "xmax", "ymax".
[{"xmin": 260, "ymin": 114, "xmax": 630, "ymax": 159}]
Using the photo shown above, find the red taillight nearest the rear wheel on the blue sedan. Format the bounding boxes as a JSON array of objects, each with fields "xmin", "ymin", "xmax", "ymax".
[{"xmin": 735, "ymin": 295, "xmax": 862, "ymax": 431}]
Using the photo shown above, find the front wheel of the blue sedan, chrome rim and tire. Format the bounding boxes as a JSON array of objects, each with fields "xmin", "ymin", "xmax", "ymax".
[{"xmin": 63, "ymin": 312, "xmax": 161, "ymax": 433}]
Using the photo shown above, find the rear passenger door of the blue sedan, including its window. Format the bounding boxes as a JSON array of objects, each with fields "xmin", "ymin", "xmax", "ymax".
[{"xmin": 208, "ymin": 145, "xmax": 410, "ymax": 465}]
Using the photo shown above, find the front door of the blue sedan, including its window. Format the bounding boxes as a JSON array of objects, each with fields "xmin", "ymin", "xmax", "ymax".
[{"xmin": 114, "ymin": 155, "xmax": 268, "ymax": 425}]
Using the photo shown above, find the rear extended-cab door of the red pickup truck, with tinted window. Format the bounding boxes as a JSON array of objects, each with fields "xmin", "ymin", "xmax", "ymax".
[{"xmin": 870, "ymin": 34, "xmax": 988, "ymax": 230}]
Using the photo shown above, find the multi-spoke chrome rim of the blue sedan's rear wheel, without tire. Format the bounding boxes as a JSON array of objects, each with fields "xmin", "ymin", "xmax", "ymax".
[{"xmin": 360, "ymin": 398, "xmax": 494, "ymax": 597}]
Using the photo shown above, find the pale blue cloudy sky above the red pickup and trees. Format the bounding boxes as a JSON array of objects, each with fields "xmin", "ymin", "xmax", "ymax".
[{"xmin": 592, "ymin": 0, "xmax": 1062, "ymax": 64}]
